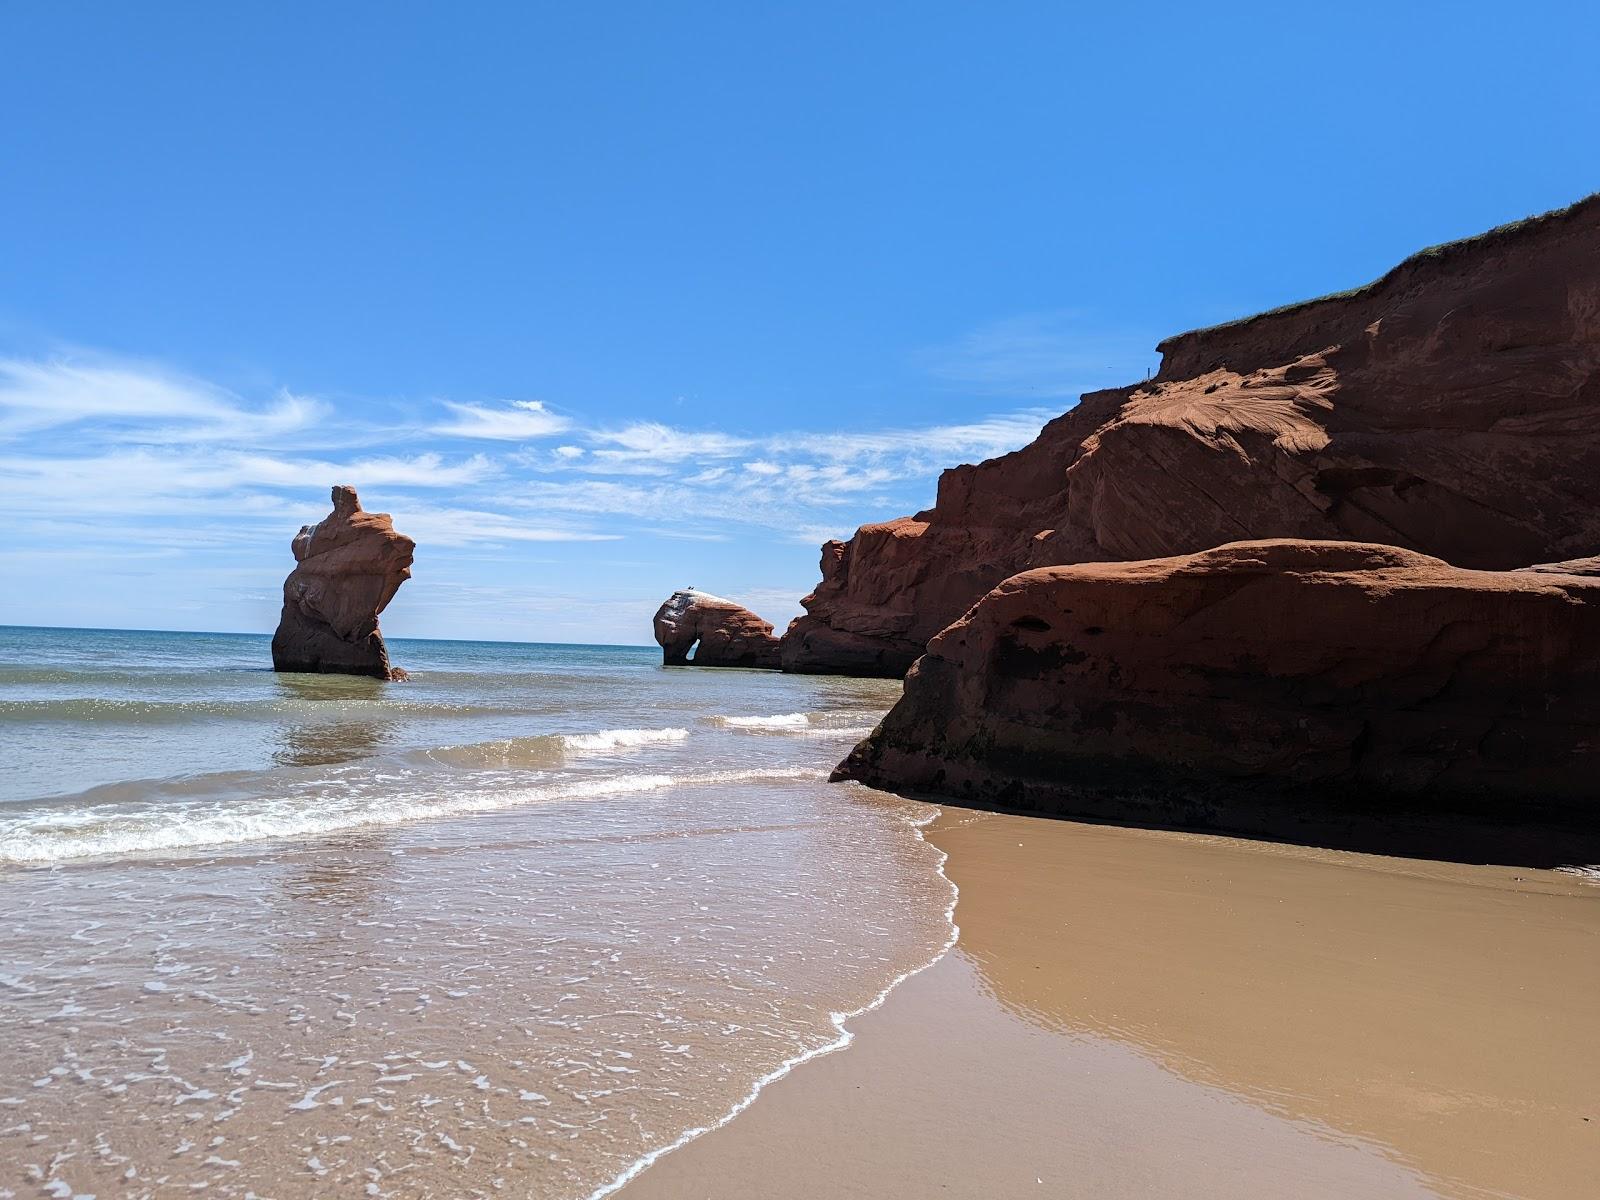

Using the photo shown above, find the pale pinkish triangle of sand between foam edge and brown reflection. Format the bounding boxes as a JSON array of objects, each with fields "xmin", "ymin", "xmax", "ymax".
[{"xmin": 622, "ymin": 950, "xmax": 1437, "ymax": 1200}]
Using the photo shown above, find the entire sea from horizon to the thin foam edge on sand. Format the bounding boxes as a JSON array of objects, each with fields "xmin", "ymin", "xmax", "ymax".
[{"xmin": 0, "ymin": 627, "xmax": 952, "ymax": 1198}]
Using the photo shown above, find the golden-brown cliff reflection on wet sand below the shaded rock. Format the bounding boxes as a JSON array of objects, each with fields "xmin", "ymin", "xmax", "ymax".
[{"xmin": 931, "ymin": 810, "xmax": 1600, "ymax": 1200}]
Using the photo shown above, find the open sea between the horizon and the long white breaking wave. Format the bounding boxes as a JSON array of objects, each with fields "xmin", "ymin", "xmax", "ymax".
[{"xmin": 0, "ymin": 627, "xmax": 891, "ymax": 844}]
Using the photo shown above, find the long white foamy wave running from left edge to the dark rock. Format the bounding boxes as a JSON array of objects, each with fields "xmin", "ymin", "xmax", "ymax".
[{"xmin": 0, "ymin": 766, "xmax": 826, "ymax": 866}]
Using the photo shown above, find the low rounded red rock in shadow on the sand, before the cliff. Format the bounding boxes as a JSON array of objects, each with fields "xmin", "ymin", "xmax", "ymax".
[{"xmin": 835, "ymin": 541, "xmax": 1600, "ymax": 853}]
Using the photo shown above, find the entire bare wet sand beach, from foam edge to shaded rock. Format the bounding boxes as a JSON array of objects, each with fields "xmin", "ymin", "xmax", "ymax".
[{"xmin": 622, "ymin": 810, "xmax": 1600, "ymax": 1200}]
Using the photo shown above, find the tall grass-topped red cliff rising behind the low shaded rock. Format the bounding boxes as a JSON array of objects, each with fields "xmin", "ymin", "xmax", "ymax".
[{"xmin": 784, "ymin": 197, "xmax": 1600, "ymax": 675}]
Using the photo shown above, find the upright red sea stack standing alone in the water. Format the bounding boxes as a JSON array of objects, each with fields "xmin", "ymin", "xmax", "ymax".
[{"xmin": 272, "ymin": 486, "xmax": 416, "ymax": 678}]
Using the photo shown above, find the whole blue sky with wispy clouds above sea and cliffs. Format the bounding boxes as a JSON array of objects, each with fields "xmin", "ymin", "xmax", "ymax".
[{"xmin": 0, "ymin": 0, "xmax": 1600, "ymax": 642}]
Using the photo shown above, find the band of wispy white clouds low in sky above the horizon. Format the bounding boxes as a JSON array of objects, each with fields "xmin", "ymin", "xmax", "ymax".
[{"xmin": 0, "ymin": 355, "xmax": 1075, "ymax": 632}]
